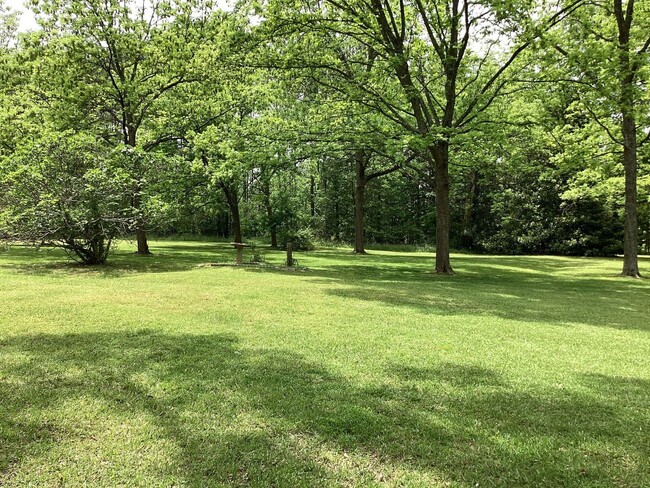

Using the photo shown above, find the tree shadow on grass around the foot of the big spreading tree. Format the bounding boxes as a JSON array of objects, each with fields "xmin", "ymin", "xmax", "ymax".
[{"xmin": 246, "ymin": 256, "xmax": 650, "ymax": 331}]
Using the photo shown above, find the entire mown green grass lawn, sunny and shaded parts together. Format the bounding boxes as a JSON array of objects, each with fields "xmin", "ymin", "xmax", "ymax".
[{"xmin": 0, "ymin": 241, "xmax": 650, "ymax": 487}]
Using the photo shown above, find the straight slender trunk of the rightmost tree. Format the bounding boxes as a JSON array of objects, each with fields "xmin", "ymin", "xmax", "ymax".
[{"xmin": 614, "ymin": 0, "xmax": 641, "ymax": 278}]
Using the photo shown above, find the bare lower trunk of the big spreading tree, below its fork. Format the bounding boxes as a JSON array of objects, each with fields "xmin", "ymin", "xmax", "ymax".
[{"xmin": 432, "ymin": 142, "xmax": 454, "ymax": 274}]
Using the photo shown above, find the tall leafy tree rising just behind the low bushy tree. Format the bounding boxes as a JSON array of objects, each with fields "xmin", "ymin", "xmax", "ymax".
[{"xmin": 28, "ymin": 0, "xmax": 202, "ymax": 254}]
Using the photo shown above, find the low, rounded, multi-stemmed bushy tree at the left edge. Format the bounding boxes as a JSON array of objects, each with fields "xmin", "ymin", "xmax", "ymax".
[{"xmin": 0, "ymin": 134, "xmax": 133, "ymax": 264}]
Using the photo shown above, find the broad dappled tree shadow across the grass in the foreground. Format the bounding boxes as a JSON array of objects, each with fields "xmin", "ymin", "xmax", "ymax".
[{"xmin": 0, "ymin": 331, "xmax": 650, "ymax": 487}]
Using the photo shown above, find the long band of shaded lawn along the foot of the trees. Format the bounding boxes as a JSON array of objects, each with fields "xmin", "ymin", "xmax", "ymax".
[{"xmin": 0, "ymin": 242, "xmax": 650, "ymax": 331}]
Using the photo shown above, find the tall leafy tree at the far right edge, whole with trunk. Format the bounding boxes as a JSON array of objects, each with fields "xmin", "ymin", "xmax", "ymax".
[{"xmin": 546, "ymin": 0, "xmax": 650, "ymax": 277}]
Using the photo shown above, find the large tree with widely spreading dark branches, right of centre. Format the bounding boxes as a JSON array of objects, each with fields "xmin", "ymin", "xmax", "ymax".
[{"xmin": 256, "ymin": 0, "xmax": 582, "ymax": 274}]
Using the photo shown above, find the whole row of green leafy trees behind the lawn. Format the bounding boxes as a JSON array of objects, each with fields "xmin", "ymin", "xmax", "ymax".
[{"xmin": 0, "ymin": 0, "xmax": 650, "ymax": 276}]
